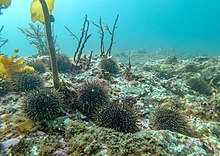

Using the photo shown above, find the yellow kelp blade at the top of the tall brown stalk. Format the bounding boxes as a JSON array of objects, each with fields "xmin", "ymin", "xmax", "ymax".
[{"xmin": 30, "ymin": 0, "xmax": 54, "ymax": 24}]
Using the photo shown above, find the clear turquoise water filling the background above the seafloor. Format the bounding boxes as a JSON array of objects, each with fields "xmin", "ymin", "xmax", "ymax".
[{"xmin": 0, "ymin": 0, "xmax": 220, "ymax": 55}]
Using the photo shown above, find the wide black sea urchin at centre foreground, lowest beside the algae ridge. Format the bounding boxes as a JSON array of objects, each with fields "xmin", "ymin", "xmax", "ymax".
[{"xmin": 94, "ymin": 104, "xmax": 138, "ymax": 133}]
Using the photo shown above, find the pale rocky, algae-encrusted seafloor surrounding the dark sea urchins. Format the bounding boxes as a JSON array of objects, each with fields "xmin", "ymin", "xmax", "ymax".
[{"xmin": 0, "ymin": 52, "xmax": 220, "ymax": 156}]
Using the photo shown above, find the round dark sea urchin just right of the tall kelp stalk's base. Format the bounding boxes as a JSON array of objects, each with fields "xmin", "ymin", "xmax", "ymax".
[{"xmin": 77, "ymin": 80, "xmax": 108, "ymax": 117}]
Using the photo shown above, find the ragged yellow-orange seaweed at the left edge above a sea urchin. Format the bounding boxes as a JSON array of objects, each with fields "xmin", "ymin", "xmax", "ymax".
[{"xmin": 0, "ymin": 50, "xmax": 34, "ymax": 80}]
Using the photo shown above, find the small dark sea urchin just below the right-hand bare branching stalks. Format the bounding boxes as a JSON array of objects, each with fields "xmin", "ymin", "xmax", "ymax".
[{"xmin": 99, "ymin": 58, "xmax": 119, "ymax": 74}]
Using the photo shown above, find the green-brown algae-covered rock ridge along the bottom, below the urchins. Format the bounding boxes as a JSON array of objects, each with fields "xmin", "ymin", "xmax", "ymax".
[{"xmin": 10, "ymin": 117, "xmax": 218, "ymax": 156}]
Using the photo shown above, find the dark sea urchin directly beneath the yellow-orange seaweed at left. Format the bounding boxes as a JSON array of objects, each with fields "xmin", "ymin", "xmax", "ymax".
[{"xmin": 12, "ymin": 71, "xmax": 43, "ymax": 92}]
